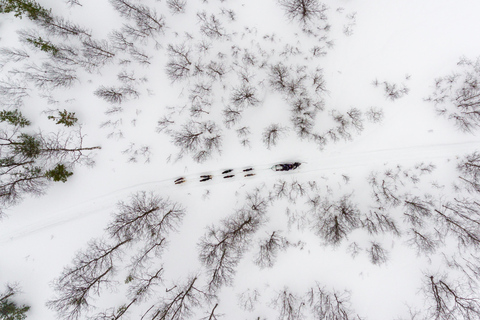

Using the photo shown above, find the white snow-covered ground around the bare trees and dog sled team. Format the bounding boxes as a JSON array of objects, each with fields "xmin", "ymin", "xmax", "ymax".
[{"xmin": 0, "ymin": 0, "xmax": 480, "ymax": 319}]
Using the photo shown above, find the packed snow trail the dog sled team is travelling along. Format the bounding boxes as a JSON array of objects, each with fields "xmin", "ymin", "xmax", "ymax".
[{"xmin": 0, "ymin": 141, "xmax": 480, "ymax": 244}]
